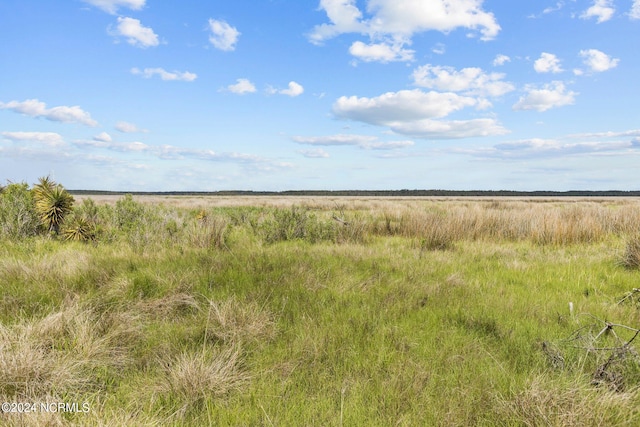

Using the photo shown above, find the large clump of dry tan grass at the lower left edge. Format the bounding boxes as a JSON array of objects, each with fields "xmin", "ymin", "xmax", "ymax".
[{"xmin": 0, "ymin": 302, "xmax": 138, "ymax": 401}]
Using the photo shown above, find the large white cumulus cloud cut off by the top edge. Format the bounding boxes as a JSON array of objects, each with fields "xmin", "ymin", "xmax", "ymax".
[{"xmin": 309, "ymin": 0, "xmax": 500, "ymax": 62}]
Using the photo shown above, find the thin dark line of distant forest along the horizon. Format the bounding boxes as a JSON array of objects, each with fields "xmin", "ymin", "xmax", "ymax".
[{"xmin": 69, "ymin": 190, "xmax": 640, "ymax": 197}]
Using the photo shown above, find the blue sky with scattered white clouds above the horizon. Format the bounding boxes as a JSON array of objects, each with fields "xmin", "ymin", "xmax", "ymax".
[{"xmin": 0, "ymin": 0, "xmax": 640, "ymax": 191}]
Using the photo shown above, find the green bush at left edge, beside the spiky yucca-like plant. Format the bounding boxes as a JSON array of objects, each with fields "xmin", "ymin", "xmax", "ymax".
[{"xmin": 0, "ymin": 183, "xmax": 40, "ymax": 240}]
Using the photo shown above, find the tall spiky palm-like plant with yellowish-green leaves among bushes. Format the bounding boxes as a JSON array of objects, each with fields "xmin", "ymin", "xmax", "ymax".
[{"xmin": 33, "ymin": 177, "xmax": 74, "ymax": 234}]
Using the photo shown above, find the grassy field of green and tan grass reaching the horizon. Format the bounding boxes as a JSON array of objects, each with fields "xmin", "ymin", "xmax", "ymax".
[{"xmin": 0, "ymin": 196, "xmax": 640, "ymax": 426}]
